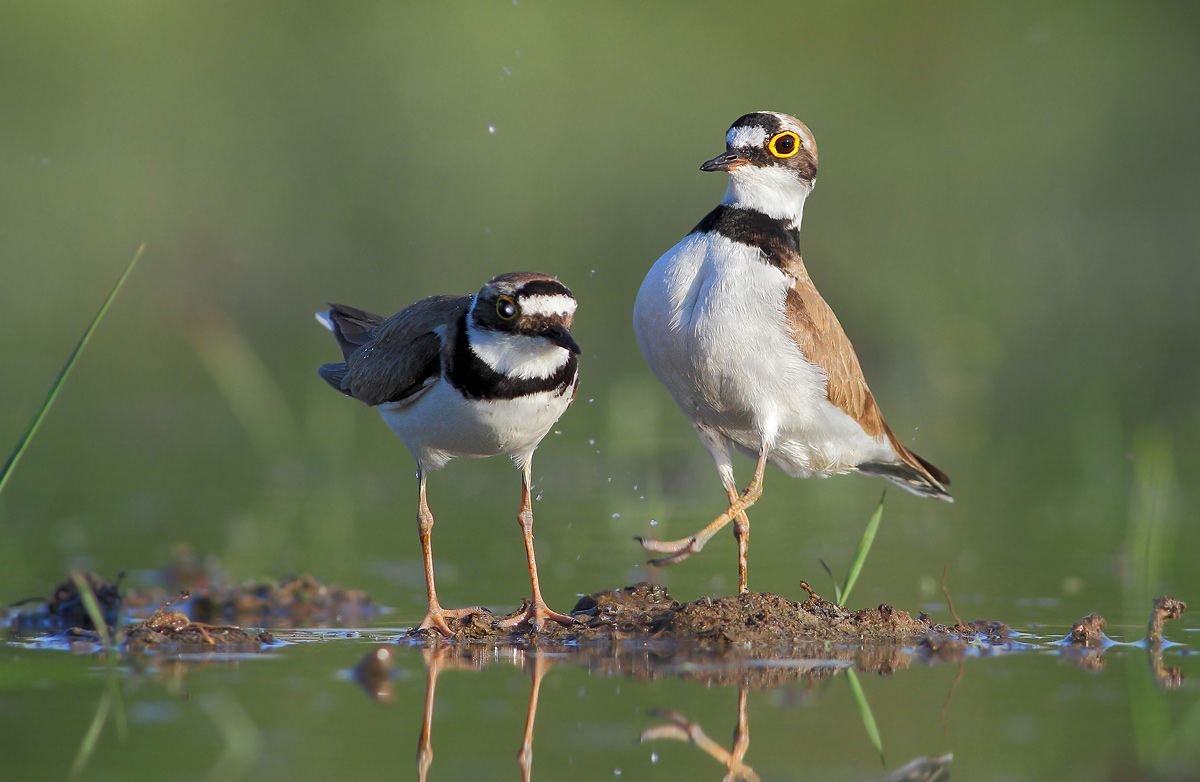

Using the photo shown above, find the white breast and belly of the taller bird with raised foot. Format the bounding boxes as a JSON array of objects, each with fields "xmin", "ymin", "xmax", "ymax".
[{"xmin": 634, "ymin": 234, "xmax": 894, "ymax": 476}]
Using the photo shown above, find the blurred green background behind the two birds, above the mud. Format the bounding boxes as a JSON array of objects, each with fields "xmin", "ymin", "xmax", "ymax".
[{"xmin": 0, "ymin": 0, "xmax": 1200, "ymax": 642}]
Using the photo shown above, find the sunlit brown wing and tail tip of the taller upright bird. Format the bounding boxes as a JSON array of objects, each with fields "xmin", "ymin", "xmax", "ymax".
[{"xmin": 784, "ymin": 255, "xmax": 950, "ymax": 499}]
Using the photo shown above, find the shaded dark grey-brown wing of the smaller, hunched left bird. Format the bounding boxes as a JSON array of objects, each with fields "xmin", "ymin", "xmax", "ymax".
[{"xmin": 330, "ymin": 291, "xmax": 470, "ymax": 405}]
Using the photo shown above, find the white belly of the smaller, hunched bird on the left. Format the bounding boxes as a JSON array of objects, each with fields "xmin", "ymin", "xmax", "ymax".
[{"xmin": 379, "ymin": 380, "xmax": 572, "ymax": 470}]
